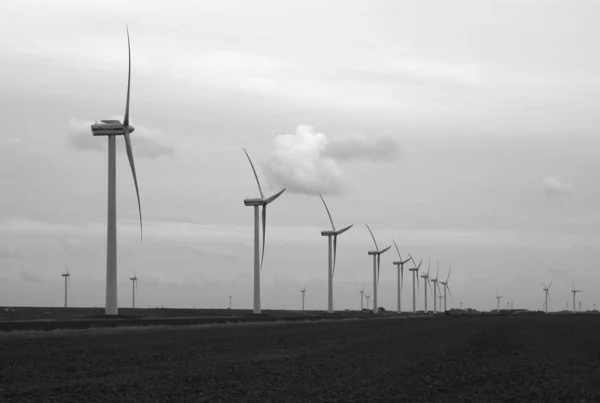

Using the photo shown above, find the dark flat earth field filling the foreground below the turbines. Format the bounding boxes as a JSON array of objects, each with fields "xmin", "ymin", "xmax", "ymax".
[{"xmin": 0, "ymin": 315, "xmax": 600, "ymax": 403}]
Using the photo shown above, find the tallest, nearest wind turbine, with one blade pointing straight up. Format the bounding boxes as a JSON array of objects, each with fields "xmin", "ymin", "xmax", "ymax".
[{"xmin": 91, "ymin": 28, "xmax": 142, "ymax": 315}]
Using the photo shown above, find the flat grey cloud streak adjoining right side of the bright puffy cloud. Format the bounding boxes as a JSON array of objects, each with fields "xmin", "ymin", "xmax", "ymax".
[{"xmin": 327, "ymin": 136, "xmax": 400, "ymax": 162}]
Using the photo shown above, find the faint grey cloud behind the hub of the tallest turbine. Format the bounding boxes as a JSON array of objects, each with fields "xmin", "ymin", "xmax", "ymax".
[{"xmin": 67, "ymin": 117, "xmax": 174, "ymax": 159}]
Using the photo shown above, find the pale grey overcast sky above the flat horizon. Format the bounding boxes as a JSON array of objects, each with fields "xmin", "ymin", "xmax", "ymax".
[{"xmin": 0, "ymin": 0, "xmax": 600, "ymax": 309}]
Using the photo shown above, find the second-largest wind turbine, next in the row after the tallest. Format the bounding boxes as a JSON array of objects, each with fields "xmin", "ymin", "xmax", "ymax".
[{"xmin": 244, "ymin": 148, "xmax": 285, "ymax": 313}]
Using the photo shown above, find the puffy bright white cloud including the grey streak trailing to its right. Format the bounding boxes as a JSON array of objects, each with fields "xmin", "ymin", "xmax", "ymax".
[{"xmin": 263, "ymin": 125, "xmax": 399, "ymax": 195}]
